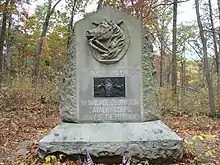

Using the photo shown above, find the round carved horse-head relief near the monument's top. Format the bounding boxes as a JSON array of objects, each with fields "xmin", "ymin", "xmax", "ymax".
[{"xmin": 86, "ymin": 19, "xmax": 130, "ymax": 64}]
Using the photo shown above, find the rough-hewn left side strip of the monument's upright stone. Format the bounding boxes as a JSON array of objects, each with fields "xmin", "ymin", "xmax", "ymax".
[{"xmin": 60, "ymin": 35, "xmax": 78, "ymax": 122}]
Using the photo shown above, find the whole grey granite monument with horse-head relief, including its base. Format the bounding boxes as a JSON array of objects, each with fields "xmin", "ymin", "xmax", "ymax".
[{"xmin": 39, "ymin": 7, "xmax": 183, "ymax": 164}]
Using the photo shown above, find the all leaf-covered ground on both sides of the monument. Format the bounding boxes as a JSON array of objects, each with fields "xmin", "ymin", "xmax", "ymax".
[{"xmin": 0, "ymin": 89, "xmax": 220, "ymax": 165}]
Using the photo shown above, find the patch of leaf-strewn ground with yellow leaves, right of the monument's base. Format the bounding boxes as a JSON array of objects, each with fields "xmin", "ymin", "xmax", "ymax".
[{"xmin": 163, "ymin": 115, "xmax": 220, "ymax": 165}]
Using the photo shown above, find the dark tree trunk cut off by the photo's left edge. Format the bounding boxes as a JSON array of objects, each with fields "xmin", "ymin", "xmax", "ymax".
[{"xmin": 0, "ymin": 0, "xmax": 9, "ymax": 88}]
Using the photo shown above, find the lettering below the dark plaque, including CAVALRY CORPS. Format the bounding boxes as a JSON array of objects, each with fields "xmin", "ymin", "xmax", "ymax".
[{"xmin": 80, "ymin": 99, "xmax": 141, "ymax": 121}]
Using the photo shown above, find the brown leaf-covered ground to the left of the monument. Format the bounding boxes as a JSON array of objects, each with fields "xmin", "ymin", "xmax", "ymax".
[{"xmin": 0, "ymin": 87, "xmax": 60, "ymax": 164}]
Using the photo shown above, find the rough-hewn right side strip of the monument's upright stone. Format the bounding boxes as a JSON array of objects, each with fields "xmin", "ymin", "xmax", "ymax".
[{"xmin": 141, "ymin": 26, "xmax": 160, "ymax": 121}]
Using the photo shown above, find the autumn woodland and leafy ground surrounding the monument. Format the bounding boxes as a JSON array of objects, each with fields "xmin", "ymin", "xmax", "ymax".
[{"xmin": 0, "ymin": 0, "xmax": 220, "ymax": 165}]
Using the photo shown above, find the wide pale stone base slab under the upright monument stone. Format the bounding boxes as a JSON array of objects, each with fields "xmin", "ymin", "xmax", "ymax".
[{"xmin": 38, "ymin": 120, "xmax": 183, "ymax": 162}]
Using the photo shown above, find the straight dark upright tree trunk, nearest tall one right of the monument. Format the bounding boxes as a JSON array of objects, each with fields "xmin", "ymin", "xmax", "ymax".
[{"xmin": 171, "ymin": 0, "xmax": 177, "ymax": 93}]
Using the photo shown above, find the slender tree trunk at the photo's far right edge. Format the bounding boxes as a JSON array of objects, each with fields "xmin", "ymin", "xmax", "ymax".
[{"xmin": 209, "ymin": 0, "xmax": 220, "ymax": 96}]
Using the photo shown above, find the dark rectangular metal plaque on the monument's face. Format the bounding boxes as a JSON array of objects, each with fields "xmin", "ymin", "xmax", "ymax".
[{"xmin": 94, "ymin": 77, "xmax": 125, "ymax": 97}]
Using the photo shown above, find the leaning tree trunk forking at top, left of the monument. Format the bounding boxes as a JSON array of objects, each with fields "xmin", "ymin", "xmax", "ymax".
[{"xmin": 33, "ymin": 0, "xmax": 61, "ymax": 83}]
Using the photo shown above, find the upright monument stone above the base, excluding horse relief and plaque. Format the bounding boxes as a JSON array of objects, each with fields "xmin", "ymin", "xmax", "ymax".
[{"xmin": 60, "ymin": 7, "xmax": 159, "ymax": 122}]
